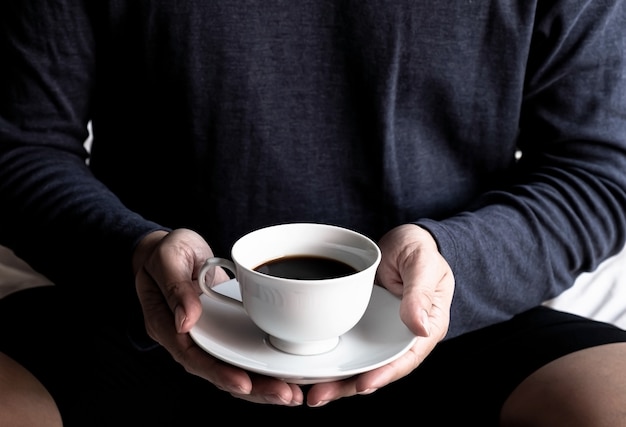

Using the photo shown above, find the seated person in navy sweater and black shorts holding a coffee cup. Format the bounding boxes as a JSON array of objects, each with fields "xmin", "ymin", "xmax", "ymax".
[{"xmin": 0, "ymin": 0, "xmax": 626, "ymax": 426}]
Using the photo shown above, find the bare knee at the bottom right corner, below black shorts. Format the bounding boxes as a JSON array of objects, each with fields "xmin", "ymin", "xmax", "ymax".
[{"xmin": 501, "ymin": 343, "xmax": 626, "ymax": 427}]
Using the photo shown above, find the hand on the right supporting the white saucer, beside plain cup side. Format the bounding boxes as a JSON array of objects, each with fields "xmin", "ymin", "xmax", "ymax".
[{"xmin": 307, "ymin": 224, "xmax": 454, "ymax": 406}]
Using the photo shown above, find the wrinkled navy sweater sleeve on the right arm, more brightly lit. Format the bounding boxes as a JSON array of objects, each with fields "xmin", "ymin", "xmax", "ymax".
[{"xmin": 418, "ymin": 1, "xmax": 626, "ymax": 337}]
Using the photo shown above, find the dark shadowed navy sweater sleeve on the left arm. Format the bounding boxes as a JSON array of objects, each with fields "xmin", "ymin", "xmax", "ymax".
[{"xmin": 0, "ymin": 0, "xmax": 165, "ymax": 290}]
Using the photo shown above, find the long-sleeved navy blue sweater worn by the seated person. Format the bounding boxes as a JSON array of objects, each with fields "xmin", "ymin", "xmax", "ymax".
[{"xmin": 0, "ymin": 0, "xmax": 626, "ymax": 337}]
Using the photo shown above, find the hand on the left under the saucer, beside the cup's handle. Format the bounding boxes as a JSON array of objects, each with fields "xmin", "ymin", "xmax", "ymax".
[{"xmin": 133, "ymin": 229, "xmax": 304, "ymax": 406}]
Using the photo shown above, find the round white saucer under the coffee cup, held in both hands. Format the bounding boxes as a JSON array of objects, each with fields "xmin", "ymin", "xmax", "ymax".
[{"xmin": 190, "ymin": 280, "xmax": 416, "ymax": 384}]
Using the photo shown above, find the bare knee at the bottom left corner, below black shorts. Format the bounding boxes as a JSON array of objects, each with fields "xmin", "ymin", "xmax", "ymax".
[{"xmin": 0, "ymin": 353, "xmax": 63, "ymax": 427}]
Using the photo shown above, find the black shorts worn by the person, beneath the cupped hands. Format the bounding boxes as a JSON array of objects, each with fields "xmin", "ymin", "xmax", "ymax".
[{"xmin": 0, "ymin": 287, "xmax": 626, "ymax": 427}]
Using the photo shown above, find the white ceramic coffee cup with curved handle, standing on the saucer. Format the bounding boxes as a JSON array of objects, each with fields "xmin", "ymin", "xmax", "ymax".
[{"xmin": 198, "ymin": 223, "xmax": 381, "ymax": 355}]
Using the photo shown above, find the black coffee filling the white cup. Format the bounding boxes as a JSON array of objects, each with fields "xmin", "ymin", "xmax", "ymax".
[{"xmin": 254, "ymin": 255, "xmax": 356, "ymax": 280}]
